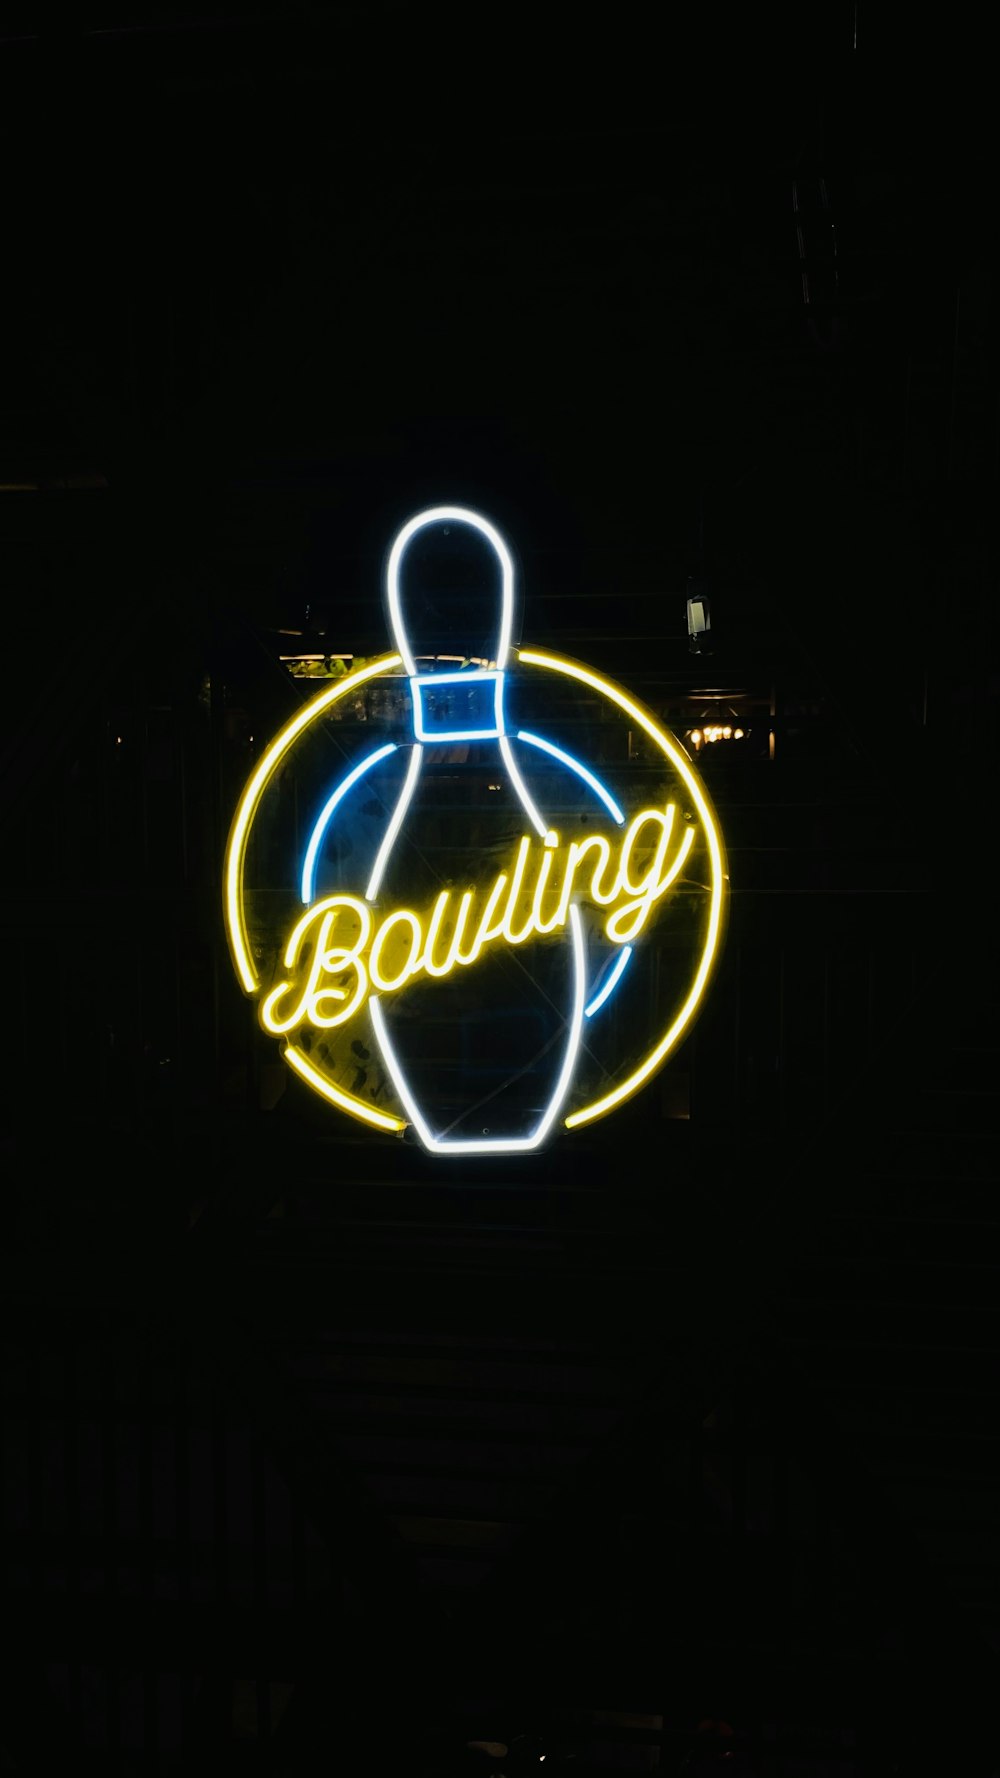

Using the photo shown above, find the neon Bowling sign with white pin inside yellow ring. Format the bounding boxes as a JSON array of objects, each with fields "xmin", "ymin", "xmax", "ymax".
[{"xmin": 224, "ymin": 507, "xmax": 728, "ymax": 1154}]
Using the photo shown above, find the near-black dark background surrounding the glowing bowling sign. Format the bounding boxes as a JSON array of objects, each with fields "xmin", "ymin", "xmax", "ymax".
[{"xmin": 0, "ymin": 5, "xmax": 1000, "ymax": 1778}]
